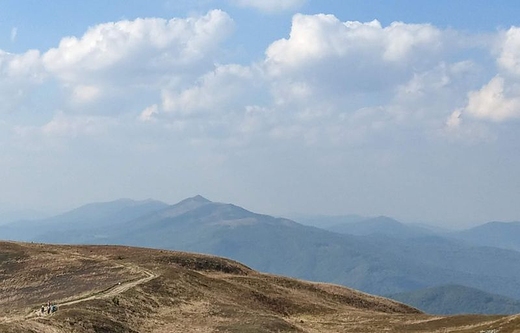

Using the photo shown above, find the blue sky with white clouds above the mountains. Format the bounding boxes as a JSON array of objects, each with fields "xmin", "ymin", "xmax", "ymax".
[{"xmin": 0, "ymin": 0, "xmax": 520, "ymax": 226}]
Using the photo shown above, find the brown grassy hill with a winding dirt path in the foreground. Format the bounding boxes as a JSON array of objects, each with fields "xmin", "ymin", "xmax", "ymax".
[{"xmin": 0, "ymin": 242, "xmax": 520, "ymax": 333}]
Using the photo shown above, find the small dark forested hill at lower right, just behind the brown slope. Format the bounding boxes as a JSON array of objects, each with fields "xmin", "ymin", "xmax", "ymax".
[{"xmin": 389, "ymin": 285, "xmax": 520, "ymax": 315}]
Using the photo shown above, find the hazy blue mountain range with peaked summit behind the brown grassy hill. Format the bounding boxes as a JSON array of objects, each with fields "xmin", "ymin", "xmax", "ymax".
[{"xmin": 0, "ymin": 196, "xmax": 520, "ymax": 314}]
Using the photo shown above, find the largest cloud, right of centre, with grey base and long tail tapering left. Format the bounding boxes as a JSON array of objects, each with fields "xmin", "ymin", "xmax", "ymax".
[{"xmin": 144, "ymin": 14, "xmax": 486, "ymax": 145}]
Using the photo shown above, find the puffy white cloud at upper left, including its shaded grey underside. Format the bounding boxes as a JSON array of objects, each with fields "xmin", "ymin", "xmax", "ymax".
[{"xmin": 42, "ymin": 10, "xmax": 234, "ymax": 107}]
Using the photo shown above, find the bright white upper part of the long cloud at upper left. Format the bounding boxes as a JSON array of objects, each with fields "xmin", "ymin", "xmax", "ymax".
[{"xmin": 43, "ymin": 10, "xmax": 233, "ymax": 81}]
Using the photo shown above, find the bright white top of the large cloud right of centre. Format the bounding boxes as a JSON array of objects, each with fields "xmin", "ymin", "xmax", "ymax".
[{"xmin": 266, "ymin": 14, "xmax": 442, "ymax": 74}]
